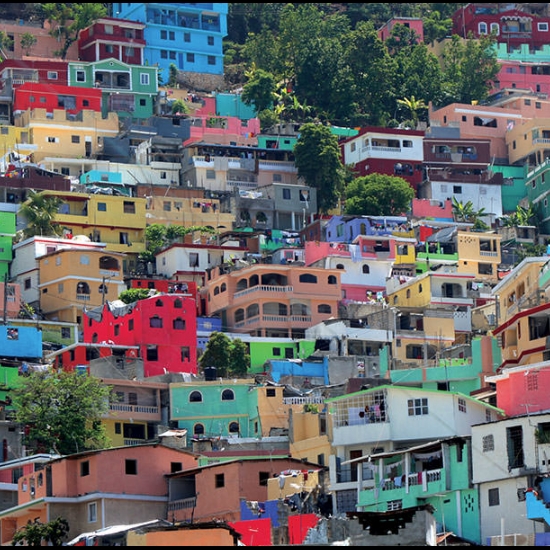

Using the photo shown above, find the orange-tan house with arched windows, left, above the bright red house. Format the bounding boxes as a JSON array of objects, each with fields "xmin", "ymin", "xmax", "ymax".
[{"xmin": 38, "ymin": 248, "xmax": 126, "ymax": 326}]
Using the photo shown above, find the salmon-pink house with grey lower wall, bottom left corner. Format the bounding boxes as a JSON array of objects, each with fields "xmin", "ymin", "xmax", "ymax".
[{"xmin": 0, "ymin": 444, "xmax": 202, "ymax": 546}]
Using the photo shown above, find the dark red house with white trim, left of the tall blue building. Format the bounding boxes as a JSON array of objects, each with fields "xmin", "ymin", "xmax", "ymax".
[{"xmin": 78, "ymin": 17, "xmax": 146, "ymax": 65}]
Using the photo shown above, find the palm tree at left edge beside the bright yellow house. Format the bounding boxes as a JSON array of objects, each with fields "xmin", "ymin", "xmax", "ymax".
[{"xmin": 18, "ymin": 189, "xmax": 63, "ymax": 238}]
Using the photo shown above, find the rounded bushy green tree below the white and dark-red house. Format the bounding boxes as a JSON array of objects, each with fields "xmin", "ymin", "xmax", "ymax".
[{"xmin": 345, "ymin": 174, "xmax": 415, "ymax": 216}]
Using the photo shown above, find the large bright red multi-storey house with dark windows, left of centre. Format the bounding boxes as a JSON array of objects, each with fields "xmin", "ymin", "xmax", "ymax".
[{"xmin": 83, "ymin": 293, "xmax": 197, "ymax": 378}]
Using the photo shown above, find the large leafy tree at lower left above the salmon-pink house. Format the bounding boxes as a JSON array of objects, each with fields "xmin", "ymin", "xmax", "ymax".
[{"xmin": 11, "ymin": 370, "xmax": 115, "ymax": 455}]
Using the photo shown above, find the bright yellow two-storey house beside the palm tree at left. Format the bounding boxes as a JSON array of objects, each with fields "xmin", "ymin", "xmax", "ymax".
[{"xmin": 37, "ymin": 190, "xmax": 146, "ymax": 272}]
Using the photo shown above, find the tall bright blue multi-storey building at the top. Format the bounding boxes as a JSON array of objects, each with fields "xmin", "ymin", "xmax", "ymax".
[{"xmin": 112, "ymin": 2, "xmax": 229, "ymax": 89}]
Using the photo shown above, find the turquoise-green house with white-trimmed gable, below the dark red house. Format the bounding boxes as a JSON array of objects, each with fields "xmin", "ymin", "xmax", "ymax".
[{"xmin": 68, "ymin": 58, "xmax": 159, "ymax": 120}]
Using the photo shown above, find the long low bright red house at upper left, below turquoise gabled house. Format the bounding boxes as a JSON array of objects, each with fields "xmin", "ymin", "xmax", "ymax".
[{"xmin": 13, "ymin": 82, "xmax": 102, "ymax": 114}]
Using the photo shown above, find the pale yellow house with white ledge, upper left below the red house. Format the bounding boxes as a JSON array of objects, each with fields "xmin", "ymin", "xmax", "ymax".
[{"xmin": 14, "ymin": 109, "xmax": 119, "ymax": 163}]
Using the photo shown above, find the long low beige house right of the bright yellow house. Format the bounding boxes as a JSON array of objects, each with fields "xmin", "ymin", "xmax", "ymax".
[{"xmin": 145, "ymin": 194, "xmax": 235, "ymax": 231}]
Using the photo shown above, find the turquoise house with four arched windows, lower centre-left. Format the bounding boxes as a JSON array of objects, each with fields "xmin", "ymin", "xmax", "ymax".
[{"xmin": 169, "ymin": 384, "xmax": 262, "ymax": 438}]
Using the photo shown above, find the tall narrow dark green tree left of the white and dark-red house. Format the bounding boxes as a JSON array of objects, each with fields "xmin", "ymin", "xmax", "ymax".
[{"xmin": 294, "ymin": 122, "xmax": 345, "ymax": 213}]
